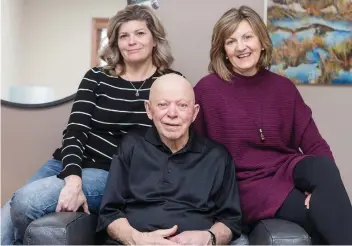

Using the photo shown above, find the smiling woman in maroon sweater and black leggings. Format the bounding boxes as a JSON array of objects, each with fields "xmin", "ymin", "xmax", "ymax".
[{"xmin": 195, "ymin": 6, "xmax": 352, "ymax": 244}]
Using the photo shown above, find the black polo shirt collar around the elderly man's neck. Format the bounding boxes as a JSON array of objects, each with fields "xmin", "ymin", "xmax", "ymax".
[{"xmin": 144, "ymin": 125, "xmax": 202, "ymax": 153}]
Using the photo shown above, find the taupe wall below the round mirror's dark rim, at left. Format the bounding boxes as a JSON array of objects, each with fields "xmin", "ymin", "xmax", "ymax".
[{"xmin": 1, "ymin": 103, "xmax": 72, "ymax": 204}]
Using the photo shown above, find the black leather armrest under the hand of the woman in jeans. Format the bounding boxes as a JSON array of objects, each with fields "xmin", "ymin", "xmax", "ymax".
[{"xmin": 23, "ymin": 212, "xmax": 97, "ymax": 245}]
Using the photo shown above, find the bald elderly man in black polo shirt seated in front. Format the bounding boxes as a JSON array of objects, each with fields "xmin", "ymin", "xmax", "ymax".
[{"xmin": 97, "ymin": 74, "xmax": 241, "ymax": 245}]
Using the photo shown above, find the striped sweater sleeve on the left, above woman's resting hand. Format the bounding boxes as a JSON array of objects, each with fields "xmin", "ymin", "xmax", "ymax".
[{"xmin": 58, "ymin": 70, "xmax": 98, "ymax": 179}]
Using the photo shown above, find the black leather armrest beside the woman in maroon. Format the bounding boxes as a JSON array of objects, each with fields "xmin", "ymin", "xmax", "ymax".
[{"xmin": 249, "ymin": 219, "xmax": 311, "ymax": 245}]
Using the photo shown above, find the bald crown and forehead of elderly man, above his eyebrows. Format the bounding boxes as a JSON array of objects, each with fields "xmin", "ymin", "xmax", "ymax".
[{"xmin": 149, "ymin": 73, "xmax": 194, "ymax": 103}]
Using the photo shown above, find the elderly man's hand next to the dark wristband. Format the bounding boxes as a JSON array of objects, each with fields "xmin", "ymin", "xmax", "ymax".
[{"xmin": 169, "ymin": 231, "xmax": 211, "ymax": 245}]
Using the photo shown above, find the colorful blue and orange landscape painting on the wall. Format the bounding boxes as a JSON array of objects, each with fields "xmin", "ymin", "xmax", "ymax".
[{"xmin": 266, "ymin": 0, "xmax": 352, "ymax": 85}]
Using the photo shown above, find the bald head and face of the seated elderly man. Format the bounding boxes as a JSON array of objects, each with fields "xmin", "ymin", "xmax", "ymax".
[{"xmin": 145, "ymin": 73, "xmax": 199, "ymax": 147}]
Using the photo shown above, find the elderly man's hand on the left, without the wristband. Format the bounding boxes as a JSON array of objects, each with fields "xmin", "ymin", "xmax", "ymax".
[{"xmin": 134, "ymin": 225, "xmax": 177, "ymax": 245}]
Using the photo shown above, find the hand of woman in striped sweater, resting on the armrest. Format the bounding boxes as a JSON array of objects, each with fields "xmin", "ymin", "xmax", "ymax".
[{"xmin": 56, "ymin": 175, "xmax": 90, "ymax": 214}]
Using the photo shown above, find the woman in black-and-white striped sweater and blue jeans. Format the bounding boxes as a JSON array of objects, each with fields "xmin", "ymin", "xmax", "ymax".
[{"xmin": 1, "ymin": 5, "xmax": 183, "ymax": 244}]
